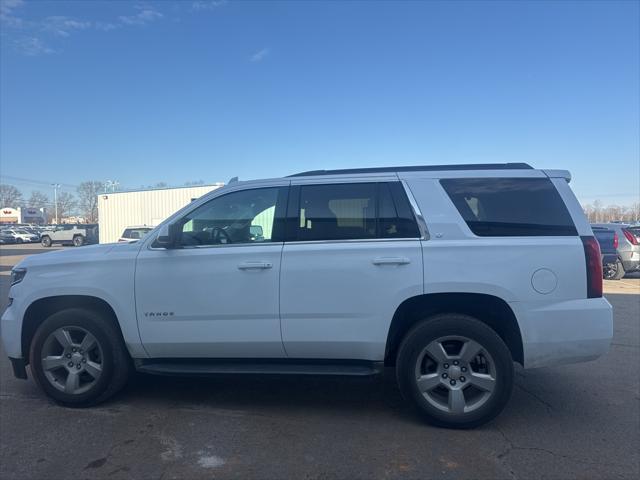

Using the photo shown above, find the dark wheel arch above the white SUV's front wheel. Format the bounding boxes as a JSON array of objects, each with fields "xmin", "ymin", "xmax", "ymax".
[{"xmin": 21, "ymin": 295, "xmax": 124, "ymax": 363}]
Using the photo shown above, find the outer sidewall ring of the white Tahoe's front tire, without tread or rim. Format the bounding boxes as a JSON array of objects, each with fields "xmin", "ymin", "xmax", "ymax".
[{"xmin": 29, "ymin": 308, "xmax": 115, "ymax": 406}]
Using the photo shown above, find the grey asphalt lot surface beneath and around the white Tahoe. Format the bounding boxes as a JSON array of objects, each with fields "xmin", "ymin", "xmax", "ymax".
[{"xmin": 0, "ymin": 246, "xmax": 640, "ymax": 480}]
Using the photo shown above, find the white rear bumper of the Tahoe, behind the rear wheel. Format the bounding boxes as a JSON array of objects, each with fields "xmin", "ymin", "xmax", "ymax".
[{"xmin": 510, "ymin": 298, "xmax": 613, "ymax": 368}]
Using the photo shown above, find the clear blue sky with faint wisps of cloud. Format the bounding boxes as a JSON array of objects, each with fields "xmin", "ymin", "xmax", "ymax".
[{"xmin": 0, "ymin": 0, "xmax": 640, "ymax": 204}]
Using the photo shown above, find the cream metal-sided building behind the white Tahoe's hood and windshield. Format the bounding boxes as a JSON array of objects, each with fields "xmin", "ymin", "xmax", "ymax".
[{"xmin": 98, "ymin": 183, "xmax": 224, "ymax": 243}]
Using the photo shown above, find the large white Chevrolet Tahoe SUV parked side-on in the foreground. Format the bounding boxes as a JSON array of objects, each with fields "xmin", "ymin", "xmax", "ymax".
[{"xmin": 2, "ymin": 164, "xmax": 612, "ymax": 427}]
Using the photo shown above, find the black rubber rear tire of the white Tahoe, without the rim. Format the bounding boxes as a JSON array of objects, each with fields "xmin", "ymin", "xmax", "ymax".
[{"xmin": 396, "ymin": 314, "xmax": 514, "ymax": 428}]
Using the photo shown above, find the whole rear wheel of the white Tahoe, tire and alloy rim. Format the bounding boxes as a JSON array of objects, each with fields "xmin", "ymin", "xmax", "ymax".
[{"xmin": 396, "ymin": 314, "xmax": 513, "ymax": 428}]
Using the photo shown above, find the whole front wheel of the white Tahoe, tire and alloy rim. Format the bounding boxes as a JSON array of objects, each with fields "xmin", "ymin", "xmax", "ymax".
[{"xmin": 29, "ymin": 308, "xmax": 131, "ymax": 407}]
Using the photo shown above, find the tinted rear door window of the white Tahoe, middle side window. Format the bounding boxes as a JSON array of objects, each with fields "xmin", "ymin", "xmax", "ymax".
[{"xmin": 292, "ymin": 182, "xmax": 420, "ymax": 241}]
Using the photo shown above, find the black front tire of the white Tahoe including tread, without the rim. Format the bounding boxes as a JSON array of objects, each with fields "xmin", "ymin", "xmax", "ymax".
[{"xmin": 29, "ymin": 308, "xmax": 132, "ymax": 407}]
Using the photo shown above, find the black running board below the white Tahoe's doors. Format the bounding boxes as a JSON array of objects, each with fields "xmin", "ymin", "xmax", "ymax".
[{"xmin": 135, "ymin": 358, "xmax": 384, "ymax": 377}]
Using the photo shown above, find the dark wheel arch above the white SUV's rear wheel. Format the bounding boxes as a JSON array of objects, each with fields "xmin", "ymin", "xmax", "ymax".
[{"xmin": 385, "ymin": 292, "xmax": 524, "ymax": 366}]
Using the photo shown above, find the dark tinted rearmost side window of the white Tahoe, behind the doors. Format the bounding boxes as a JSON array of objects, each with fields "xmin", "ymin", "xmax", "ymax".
[{"xmin": 440, "ymin": 178, "xmax": 577, "ymax": 237}]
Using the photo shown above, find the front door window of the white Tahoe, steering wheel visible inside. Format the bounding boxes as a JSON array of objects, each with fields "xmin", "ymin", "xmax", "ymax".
[{"xmin": 180, "ymin": 187, "xmax": 286, "ymax": 246}]
